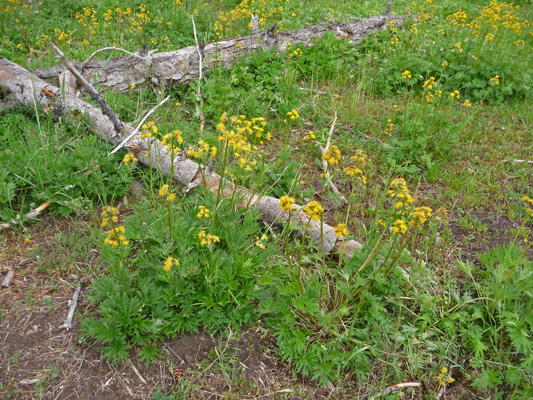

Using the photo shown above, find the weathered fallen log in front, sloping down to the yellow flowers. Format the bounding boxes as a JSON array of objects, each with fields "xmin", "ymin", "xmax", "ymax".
[{"xmin": 0, "ymin": 57, "xmax": 361, "ymax": 257}]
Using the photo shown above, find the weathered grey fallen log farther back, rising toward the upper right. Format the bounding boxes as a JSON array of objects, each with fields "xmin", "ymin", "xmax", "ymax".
[{"xmin": 34, "ymin": 15, "xmax": 407, "ymax": 91}]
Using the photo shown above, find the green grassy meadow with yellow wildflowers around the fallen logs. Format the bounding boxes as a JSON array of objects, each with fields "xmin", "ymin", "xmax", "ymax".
[{"xmin": 0, "ymin": 0, "xmax": 533, "ymax": 399}]
